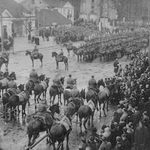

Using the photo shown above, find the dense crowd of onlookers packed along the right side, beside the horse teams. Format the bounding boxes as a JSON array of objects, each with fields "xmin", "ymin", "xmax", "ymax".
[{"xmin": 81, "ymin": 52, "xmax": 150, "ymax": 150}]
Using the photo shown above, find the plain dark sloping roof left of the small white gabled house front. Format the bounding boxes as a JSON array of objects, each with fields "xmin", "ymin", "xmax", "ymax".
[{"xmin": 39, "ymin": 9, "xmax": 71, "ymax": 27}]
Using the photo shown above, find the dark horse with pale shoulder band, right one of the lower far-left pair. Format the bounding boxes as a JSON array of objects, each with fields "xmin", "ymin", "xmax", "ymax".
[{"xmin": 8, "ymin": 90, "xmax": 30, "ymax": 119}]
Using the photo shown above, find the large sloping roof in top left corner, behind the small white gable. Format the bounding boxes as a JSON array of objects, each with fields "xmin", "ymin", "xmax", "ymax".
[{"xmin": 0, "ymin": 0, "xmax": 28, "ymax": 18}]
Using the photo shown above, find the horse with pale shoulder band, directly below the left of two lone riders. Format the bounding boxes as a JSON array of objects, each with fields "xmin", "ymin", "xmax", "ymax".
[{"xmin": 33, "ymin": 78, "xmax": 49, "ymax": 108}]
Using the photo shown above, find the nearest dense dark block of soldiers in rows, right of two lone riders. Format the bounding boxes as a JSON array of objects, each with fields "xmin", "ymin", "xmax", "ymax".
[{"xmin": 76, "ymin": 32, "xmax": 149, "ymax": 61}]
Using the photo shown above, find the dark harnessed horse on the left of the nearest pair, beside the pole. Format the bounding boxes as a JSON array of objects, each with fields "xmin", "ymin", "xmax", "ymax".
[{"xmin": 27, "ymin": 104, "xmax": 60, "ymax": 146}]
